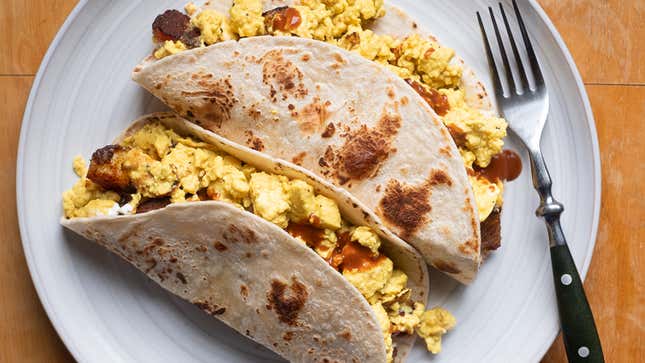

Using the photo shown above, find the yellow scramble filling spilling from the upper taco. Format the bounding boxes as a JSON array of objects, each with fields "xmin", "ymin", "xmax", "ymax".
[{"xmin": 153, "ymin": 0, "xmax": 507, "ymax": 221}]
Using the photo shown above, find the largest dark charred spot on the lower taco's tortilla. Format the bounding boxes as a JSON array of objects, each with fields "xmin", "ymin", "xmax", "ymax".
[{"xmin": 267, "ymin": 277, "xmax": 309, "ymax": 326}]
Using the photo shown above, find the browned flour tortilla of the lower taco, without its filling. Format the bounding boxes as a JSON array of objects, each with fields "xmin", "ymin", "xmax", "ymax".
[{"xmin": 61, "ymin": 113, "xmax": 428, "ymax": 362}]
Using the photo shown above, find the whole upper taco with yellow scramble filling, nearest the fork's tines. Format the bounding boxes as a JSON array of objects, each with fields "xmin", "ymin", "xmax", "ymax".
[{"xmin": 133, "ymin": 0, "xmax": 519, "ymax": 283}]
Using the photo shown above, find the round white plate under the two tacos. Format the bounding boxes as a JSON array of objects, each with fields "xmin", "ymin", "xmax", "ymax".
[{"xmin": 16, "ymin": 0, "xmax": 600, "ymax": 362}]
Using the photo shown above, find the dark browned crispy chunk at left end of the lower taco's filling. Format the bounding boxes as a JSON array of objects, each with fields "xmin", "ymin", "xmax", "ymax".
[{"xmin": 87, "ymin": 145, "xmax": 133, "ymax": 192}]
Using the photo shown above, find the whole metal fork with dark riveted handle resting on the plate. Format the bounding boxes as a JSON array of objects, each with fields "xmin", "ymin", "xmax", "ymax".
[{"xmin": 477, "ymin": 0, "xmax": 604, "ymax": 362}]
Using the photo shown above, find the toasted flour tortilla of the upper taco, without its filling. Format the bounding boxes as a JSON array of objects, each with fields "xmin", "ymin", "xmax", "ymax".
[{"xmin": 133, "ymin": 36, "xmax": 481, "ymax": 283}]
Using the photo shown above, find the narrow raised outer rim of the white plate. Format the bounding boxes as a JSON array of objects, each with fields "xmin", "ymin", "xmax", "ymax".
[{"xmin": 16, "ymin": 0, "xmax": 602, "ymax": 362}]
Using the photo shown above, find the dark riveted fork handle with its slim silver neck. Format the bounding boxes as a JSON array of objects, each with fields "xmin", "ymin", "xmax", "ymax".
[{"xmin": 530, "ymin": 149, "xmax": 605, "ymax": 363}]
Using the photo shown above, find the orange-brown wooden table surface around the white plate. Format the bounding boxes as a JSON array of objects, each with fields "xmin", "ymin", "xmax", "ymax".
[{"xmin": 0, "ymin": 0, "xmax": 645, "ymax": 362}]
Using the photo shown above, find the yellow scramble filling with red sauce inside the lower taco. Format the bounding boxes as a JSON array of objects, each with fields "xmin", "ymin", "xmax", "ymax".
[{"xmin": 63, "ymin": 123, "xmax": 456, "ymax": 362}]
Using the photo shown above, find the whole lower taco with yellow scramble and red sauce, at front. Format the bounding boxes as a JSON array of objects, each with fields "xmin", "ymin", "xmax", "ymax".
[{"xmin": 61, "ymin": 113, "xmax": 455, "ymax": 362}]
